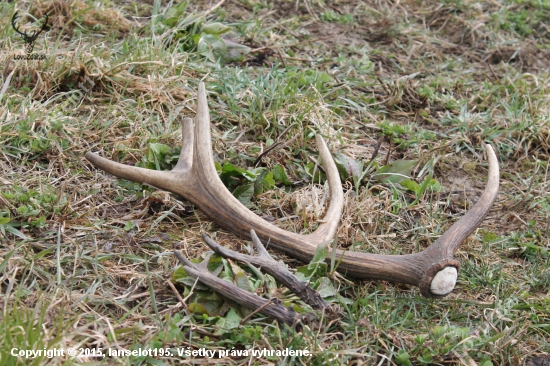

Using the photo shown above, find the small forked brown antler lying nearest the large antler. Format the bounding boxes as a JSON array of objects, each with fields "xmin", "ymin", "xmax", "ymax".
[{"xmin": 202, "ymin": 230, "xmax": 328, "ymax": 309}]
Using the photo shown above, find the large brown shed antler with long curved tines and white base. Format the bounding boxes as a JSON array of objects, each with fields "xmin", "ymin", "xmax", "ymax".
[{"xmin": 85, "ymin": 83, "xmax": 499, "ymax": 297}]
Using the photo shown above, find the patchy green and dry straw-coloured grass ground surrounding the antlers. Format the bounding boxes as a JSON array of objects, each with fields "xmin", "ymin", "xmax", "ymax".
[{"xmin": 0, "ymin": 0, "xmax": 550, "ymax": 366}]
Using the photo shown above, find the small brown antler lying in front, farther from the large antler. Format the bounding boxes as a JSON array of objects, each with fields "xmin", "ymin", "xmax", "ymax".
[{"xmin": 174, "ymin": 251, "xmax": 299, "ymax": 326}]
